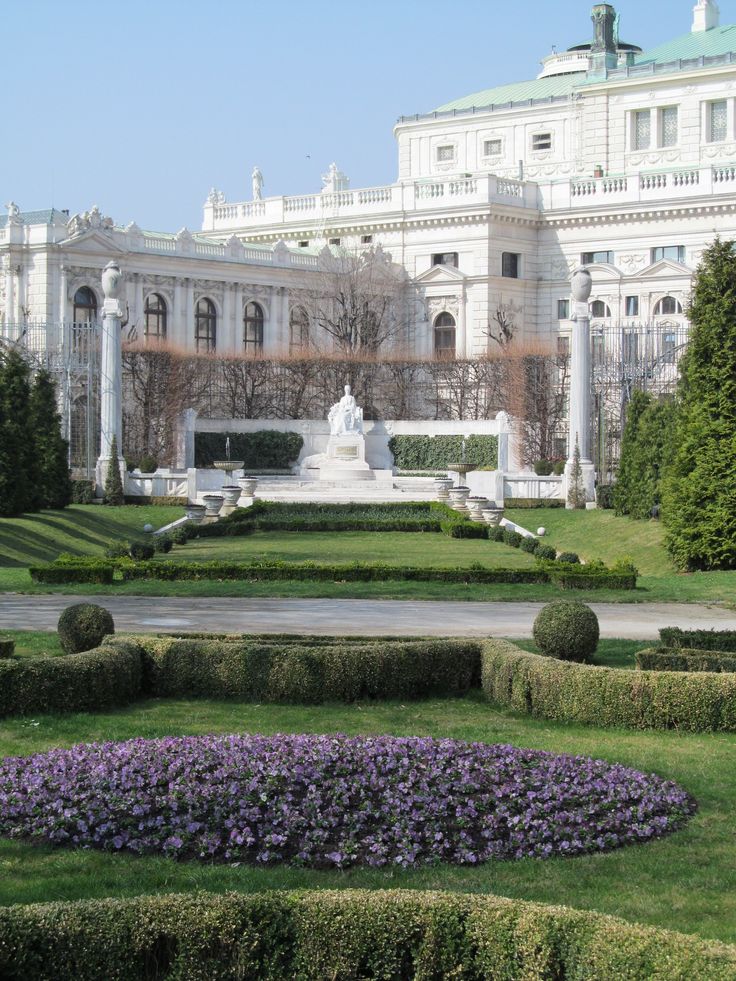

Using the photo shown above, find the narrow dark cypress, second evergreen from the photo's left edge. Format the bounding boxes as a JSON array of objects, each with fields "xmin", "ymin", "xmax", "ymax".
[{"xmin": 30, "ymin": 369, "xmax": 72, "ymax": 508}]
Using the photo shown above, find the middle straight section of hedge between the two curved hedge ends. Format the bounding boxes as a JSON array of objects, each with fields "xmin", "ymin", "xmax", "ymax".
[{"xmin": 137, "ymin": 637, "xmax": 480, "ymax": 704}]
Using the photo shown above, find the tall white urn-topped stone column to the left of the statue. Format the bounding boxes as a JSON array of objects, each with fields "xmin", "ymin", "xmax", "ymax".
[{"xmin": 97, "ymin": 262, "xmax": 125, "ymax": 494}]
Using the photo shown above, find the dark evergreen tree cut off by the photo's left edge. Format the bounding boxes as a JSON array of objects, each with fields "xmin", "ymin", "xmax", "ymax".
[{"xmin": 0, "ymin": 349, "xmax": 36, "ymax": 517}]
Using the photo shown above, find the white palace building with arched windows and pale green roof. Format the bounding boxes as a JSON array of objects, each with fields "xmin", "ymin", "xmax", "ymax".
[{"xmin": 0, "ymin": 0, "xmax": 736, "ymax": 363}]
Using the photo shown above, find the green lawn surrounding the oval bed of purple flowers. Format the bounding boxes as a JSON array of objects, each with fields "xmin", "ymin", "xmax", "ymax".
[{"xmin": 0, "ymin": 694, "xmax": 736, "ymax": 943}]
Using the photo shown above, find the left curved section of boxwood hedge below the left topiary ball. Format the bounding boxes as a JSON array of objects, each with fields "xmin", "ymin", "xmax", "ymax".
[{"xmin": 0, "ymin": 640, "xmax": 142, "ymax": 716}]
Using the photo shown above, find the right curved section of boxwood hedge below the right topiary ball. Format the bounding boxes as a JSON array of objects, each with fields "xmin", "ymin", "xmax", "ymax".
[{"xmin": 481, "ymin": 640, "xmax": 736, "ymax": 732}]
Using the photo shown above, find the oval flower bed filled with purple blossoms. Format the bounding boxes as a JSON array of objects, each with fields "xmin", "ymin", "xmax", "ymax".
[{"xmin": 0, "ymin": 735, "xmax": 695, "ymax": 867}]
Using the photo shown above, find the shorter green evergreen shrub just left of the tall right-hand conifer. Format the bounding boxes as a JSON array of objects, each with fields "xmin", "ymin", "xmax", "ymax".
[{"xmin": 613, "ymin": 391, "xmax": 676, "ymax": 518}]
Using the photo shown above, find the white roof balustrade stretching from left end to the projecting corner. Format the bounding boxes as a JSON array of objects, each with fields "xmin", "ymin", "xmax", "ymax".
[{"xmin": 202, "ymin": 174, "xmax": 537, "ymax": 234}]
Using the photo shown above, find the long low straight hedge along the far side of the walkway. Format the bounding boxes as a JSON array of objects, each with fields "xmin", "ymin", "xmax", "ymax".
[{"xmin": 121, "ymin": 560, "xmax": 550, "ymax": 583}]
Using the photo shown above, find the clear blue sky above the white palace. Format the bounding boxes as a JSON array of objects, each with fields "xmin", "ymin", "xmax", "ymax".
[{"xmin": 0, "ymin": 0, "xmax": 736, "ymax": 231}]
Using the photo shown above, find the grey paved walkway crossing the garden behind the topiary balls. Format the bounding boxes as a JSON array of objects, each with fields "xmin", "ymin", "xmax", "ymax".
[{"xmin": 0, "ymin": 593, "xmax": 736, "ymax": 640}]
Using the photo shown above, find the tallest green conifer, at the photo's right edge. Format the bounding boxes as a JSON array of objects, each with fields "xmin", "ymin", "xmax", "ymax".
[{"xmin": 662, "ymin": 239, "xmax": 736, "ymax": 569}]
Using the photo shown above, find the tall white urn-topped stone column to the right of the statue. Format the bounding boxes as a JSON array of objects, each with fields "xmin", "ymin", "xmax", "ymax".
[{"xmin": 565, "ymin": 267, "xmax": 595, "ymax": 501}]
